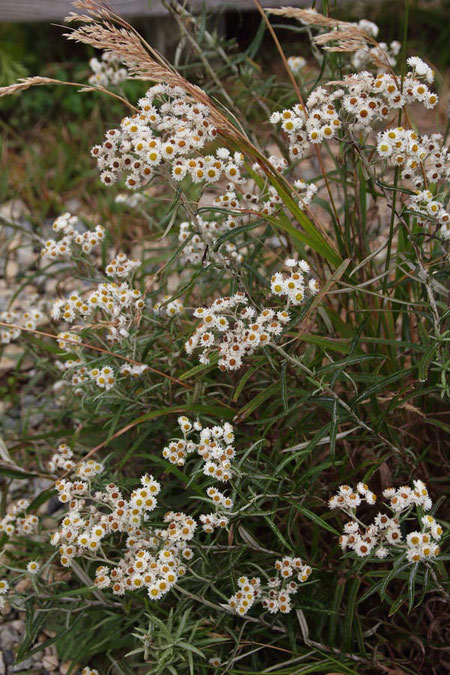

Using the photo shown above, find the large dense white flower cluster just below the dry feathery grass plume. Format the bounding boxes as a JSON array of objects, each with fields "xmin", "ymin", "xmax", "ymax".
[{"xmin": 91, "ymin": 84, "xmax": 244, "ymax": 189}]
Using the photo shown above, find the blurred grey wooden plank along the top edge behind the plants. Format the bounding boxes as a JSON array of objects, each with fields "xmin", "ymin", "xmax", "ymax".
[{"xmin": 0, "ymin": 0, "xmax": 309, "ymax": 22}]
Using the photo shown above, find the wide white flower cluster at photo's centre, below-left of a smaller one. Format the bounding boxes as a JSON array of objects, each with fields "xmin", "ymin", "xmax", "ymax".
[{"xmin": 185, "ymin": 292, "xmax": 290, "ymax": 371}]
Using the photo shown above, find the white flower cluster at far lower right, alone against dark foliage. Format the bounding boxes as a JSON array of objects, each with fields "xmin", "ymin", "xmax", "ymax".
[{"xmin": 329, "ymin": 480, "xmax": 442, "ymax": 562}]
